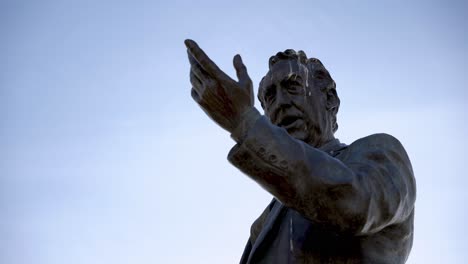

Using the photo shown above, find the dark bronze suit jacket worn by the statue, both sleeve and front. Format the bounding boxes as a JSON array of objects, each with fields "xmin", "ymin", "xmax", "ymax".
[{"xmin": 228, "ymin": 117, "xmax": 416, "ymax": 264}]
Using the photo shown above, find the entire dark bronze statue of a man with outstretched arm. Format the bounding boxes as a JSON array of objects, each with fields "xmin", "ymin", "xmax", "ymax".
[{"xmin": 185, "ymin": 40, "xmax": 416, "ymax": 264}]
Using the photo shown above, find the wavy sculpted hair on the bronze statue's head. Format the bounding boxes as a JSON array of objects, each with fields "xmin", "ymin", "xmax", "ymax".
[{"xmin": 257, "ymin": 49, "xmax": 340, "ymax": 132}]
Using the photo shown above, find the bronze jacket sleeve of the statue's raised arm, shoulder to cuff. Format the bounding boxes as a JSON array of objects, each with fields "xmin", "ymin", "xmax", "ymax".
[{"xmin": 228, "ymin": 116, "xmax": 416, "ymax": 235}]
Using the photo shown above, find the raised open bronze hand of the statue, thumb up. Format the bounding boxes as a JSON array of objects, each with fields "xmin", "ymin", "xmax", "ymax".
[{"xmin": 185, "ymin": 39, "xmax": 254, "ymax": 133}]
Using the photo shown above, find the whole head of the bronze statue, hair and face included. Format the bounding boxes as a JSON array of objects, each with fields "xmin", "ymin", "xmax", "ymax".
[{"xmin": 258, "ymin": 49, "xmax": 340, "ymax": 147}]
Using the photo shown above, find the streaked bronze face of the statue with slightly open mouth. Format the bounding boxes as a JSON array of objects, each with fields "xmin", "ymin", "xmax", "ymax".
[{"xmin": 262, "ymin": 60, "xmax": 333, "ymax": 147}]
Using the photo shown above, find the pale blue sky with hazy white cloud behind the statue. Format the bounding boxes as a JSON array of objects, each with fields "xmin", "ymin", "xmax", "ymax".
[{"xmin": 0, "ymin": 0, "xmax": 468, "ymax": 264}]
